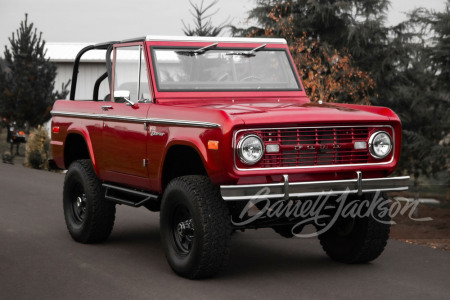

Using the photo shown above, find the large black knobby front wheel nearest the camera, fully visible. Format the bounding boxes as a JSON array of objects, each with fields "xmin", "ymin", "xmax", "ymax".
[{"xmin": 160, "ymin": 175, "xmax": 231, "ymax": 279}]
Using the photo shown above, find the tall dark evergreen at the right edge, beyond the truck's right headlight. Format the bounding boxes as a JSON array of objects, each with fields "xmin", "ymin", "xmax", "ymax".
[{"xmin": 388, "ymin": 6, "xmax": 450, "ymax": 192}]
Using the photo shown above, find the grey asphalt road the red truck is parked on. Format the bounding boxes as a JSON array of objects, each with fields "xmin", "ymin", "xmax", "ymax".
[{"xmin": 0, "ymin": 164, "xmax": 450, "ymax": 300}]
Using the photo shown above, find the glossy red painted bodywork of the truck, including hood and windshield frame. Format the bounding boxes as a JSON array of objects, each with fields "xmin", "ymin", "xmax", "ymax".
[{"xmin": 51, "ymin": 41, "xmax": 401, "ymax": 192}]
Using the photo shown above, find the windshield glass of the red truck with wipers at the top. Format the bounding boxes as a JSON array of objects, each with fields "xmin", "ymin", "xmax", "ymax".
[{"xmin": 152, "ymin": 45, "xmax": 300, "ymax": 91}]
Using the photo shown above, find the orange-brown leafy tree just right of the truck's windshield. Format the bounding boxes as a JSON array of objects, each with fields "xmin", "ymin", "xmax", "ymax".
[{"xmin": 236, "ymin": 1, "xmax": 375, "ymax": 104}]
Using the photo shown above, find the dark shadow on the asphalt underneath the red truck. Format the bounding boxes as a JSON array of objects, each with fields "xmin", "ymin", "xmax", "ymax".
[{"xmin": 103, "ymin": 225, "xmax": 370, "ymax": 280}]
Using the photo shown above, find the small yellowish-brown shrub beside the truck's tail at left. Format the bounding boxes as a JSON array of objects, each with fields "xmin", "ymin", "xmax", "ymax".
[{"xmin": 25, "ymin": 126, "xmax": 50, "ymax": 170}]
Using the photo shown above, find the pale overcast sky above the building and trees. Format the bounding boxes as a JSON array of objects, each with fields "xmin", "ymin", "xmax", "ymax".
[{"xmin": 0, "ymin": 0, "xmax": 446, "ymax": 52}]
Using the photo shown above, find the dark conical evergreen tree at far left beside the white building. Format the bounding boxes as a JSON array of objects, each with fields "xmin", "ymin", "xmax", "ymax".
[{"xmin": 0, "ymin": 14, "xmax": 69, "ymax": 127}]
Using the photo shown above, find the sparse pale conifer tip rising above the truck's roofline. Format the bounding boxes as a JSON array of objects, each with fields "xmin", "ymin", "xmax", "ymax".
[{"xmin": 181, "ymin": 0, "xmax": 229, "ymax": 36}]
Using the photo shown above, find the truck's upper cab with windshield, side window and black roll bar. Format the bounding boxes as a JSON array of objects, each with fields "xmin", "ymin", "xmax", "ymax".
[{"xmin": 70, "ymin": 35, "xmax": 302, "ymax": 102}]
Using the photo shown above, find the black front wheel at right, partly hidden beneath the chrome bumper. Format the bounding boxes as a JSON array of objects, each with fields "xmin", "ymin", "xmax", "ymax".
[{"xmin": 319, "ymin": 194, "xmax": 391, "ymax": 263}]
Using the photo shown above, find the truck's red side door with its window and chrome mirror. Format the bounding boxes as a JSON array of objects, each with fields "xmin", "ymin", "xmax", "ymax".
[{"xmin": 103, "ymin": 44, "xmax": 150, "ymax": 179}]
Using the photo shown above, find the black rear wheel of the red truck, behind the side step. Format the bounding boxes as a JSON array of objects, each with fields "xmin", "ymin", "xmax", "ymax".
[{"xmin": 63, "ymin": 159, "xmax": 116, "ymax": 243}]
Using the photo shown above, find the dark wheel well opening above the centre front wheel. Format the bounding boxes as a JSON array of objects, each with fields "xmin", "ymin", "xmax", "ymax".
[{"xmin": 162, "ymin": 145, "xmax": 208, "ymax": 190}]
